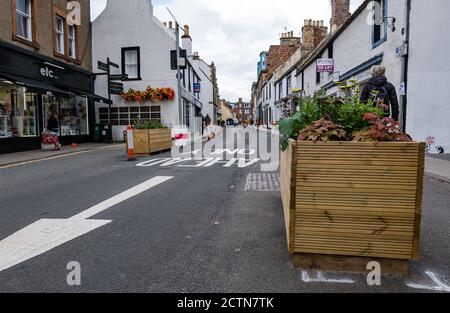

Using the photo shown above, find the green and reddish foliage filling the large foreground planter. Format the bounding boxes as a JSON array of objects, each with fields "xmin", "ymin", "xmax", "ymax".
[{"xmin": 280, "ymin": 83, "xmax": 410, "ymax": 151}]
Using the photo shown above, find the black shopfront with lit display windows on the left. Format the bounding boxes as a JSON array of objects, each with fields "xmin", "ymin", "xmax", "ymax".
[{"xmin": 0, "ymin": 41, "xmax": 107, "ymax": 154}]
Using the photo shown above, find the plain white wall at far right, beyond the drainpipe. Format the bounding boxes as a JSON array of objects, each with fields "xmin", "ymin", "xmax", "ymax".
[{"xmin": 407, "ymin": 0, "xmax": 450, "ymax": 153}]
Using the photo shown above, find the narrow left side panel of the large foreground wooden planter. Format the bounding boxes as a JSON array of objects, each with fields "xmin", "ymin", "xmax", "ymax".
[{"xmin": 280, "ymin": 140, "xmax": 297, "ymax": 253}]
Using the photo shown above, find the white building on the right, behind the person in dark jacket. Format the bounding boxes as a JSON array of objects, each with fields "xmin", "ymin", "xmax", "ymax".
[{"xmin": 296, "ymin": 0, "xmax": 450, "ymax": 152}]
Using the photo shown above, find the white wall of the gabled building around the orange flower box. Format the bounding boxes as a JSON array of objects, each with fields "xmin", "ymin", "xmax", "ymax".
[{"xmin": 92, "ymin": 0, "xmax": 178, "ymax": 141}]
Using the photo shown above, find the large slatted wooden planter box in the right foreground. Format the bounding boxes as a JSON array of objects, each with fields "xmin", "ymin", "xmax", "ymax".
[{"xmin": 280, "ymin": 140, "xmax": 425, "ymax": 271}]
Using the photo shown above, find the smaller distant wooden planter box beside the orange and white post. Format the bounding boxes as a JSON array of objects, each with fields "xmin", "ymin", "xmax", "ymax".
[{"xmin": 127, "ymin": 128, "xmax": 172, "ymax": 155}]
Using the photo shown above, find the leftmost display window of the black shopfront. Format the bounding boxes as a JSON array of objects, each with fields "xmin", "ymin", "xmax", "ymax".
[{"xmin": 0, "ymin": 82, "xmax": 38, "ymax": 138}]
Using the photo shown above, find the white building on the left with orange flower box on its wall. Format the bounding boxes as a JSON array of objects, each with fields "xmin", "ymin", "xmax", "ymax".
[{"xmin": 92, "ymin": 0, "xmax": 216, "ymax": 141}]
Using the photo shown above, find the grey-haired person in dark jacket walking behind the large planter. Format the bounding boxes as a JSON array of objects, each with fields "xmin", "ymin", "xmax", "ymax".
[{"xmin": 361, "ymin": 66, "xmax": 400, "ymax": 121}]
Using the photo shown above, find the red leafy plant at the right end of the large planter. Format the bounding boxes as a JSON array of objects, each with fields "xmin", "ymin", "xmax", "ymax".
[{"xmin": 353, "ymin": 113, "xmax": 412, "ymax": 142}]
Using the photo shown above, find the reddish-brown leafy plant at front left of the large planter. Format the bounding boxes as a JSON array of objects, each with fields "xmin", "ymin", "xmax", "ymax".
[{"xmin": 298, "ymin": 118, "xmax": 347, "ymax": 142}]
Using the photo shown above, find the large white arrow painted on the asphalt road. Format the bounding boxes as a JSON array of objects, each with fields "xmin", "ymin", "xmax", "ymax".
[{"xmin": 0, "ymin": 176, "xmax": 173, "ymax": 272}]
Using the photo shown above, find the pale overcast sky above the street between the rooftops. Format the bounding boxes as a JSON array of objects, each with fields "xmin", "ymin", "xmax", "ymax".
[{"xmin": 91, "ymin": 0, "xmax": 363, "ymax": 101}]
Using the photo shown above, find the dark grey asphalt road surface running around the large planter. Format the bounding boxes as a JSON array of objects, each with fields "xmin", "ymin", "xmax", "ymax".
[{"xmin": 0, "ymin": 127, "xmax": 450, "ymax": 293}]
